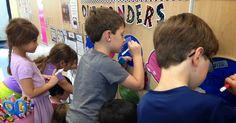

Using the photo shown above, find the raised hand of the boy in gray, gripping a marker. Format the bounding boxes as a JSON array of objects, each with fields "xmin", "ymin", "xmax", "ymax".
[{"xmin": 128, "ymin": 41, "xmax": 141, "ymax": 57}]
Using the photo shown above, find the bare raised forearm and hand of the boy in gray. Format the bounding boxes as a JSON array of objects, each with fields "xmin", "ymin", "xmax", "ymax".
[{"xmin": 121, "ymin": 41, "xmax": 144, "ymax": 90}]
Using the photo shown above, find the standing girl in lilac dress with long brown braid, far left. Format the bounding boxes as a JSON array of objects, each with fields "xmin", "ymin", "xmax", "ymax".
[{"xmin": 6, "ymin": 18, "xmax": 58, "ymax": 123}]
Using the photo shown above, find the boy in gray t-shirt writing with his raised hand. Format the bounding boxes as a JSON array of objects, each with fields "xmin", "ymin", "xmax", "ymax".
[{"xmin": 66, "ymin": 8, "xmax": 144, "ymax": 123}]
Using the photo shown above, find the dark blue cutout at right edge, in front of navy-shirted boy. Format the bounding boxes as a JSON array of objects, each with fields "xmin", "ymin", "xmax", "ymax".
[{"xmin": 200, "ymin": 57, "xmax": 236, "ymax": 106}]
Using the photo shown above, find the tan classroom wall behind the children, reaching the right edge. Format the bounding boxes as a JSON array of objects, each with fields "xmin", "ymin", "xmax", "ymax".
[{"xmin": 14, "ymin": 0, "xmax": 236, "ymax": 87}]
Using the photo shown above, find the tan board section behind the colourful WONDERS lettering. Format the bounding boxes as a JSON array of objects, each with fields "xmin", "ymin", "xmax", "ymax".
[{"xmin": 79, "ymin": 0, "xmax": 189, "ymax": 88}]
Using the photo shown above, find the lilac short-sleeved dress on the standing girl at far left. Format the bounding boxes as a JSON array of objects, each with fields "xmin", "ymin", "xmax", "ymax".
[{"xmin": 11, "ymin": 53, "xmax": 53, "ymax": 123}]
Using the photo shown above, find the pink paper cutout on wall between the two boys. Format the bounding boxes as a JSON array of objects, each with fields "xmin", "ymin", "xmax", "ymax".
[{"xmin": 145, "ymin": 50, "xmax": 161, "ymax": 82}]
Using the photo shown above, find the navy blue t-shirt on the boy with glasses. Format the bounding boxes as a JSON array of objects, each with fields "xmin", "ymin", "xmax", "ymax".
[{"xmin": 138, "ymin": 86, "xmax": 236, "ymax": 123}]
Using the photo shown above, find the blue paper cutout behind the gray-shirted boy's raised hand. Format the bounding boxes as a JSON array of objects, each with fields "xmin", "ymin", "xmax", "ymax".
[{"xmin": 118, "ymin": 35, "xmax": 143, "ymax": 67}]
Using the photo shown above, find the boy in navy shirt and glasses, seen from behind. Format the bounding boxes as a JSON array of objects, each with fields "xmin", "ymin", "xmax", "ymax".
[{"xmin": 138, "ymin": 13, "xmax": 236, "ymax": 123}]
